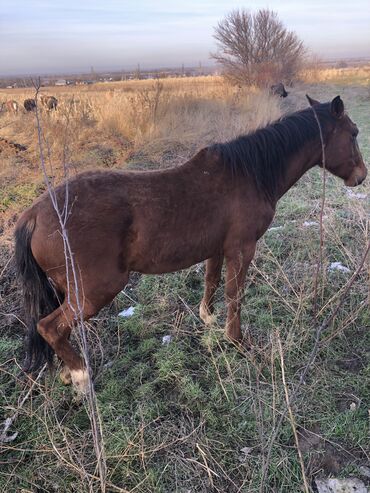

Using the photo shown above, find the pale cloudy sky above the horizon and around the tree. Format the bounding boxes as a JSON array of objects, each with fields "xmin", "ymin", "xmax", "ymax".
[{"xmin": 0, "ymin": 0, "xmax": 370, "ymax": 75}]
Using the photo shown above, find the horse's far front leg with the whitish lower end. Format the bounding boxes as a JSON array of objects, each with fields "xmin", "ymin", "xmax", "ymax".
[{"xmin": 199, "ymin": 253, "xmax": 224, "ymax": 325}]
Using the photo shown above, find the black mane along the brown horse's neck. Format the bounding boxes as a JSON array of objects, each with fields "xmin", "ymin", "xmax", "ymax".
[{"xmin": 209, "ymin": 103, "xmax": 334, "ymax": 199}]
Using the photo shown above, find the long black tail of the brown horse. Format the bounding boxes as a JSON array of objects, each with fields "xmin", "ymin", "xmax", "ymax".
[{"xmin": 15, "ymin": 218, "xmax": 59, "ymax": 373}]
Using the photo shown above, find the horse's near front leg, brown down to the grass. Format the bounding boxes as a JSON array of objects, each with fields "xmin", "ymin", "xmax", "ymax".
[{"xmin": 225, "ymin": 243, "xmax": 256, "ymax": 341}]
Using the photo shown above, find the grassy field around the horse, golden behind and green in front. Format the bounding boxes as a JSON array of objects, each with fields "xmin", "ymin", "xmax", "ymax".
[{"xmin": 0, "ymin": 77, "xmax": 370, "ymax": 493}]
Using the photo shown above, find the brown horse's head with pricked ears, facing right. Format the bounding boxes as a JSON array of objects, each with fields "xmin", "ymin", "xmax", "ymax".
[{"xmin": 307, "ymin": 96, "xmax": 367, "ymax": 187}]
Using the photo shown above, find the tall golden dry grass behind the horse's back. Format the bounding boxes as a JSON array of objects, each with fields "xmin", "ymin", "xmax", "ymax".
[{"xmin": 0, "ymin": 77, "xmax": 280, "ymax": 184}]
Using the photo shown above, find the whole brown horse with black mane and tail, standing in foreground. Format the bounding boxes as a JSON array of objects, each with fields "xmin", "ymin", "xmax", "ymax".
[{"xmin": 15, "ymin": 96, "xmax": 367, "ymax": 391}]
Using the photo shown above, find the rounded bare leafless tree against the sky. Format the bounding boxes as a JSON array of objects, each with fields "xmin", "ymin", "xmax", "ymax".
[{"xmin": 211, "ymin": 9, "xmax": 305, "ymax": 86}]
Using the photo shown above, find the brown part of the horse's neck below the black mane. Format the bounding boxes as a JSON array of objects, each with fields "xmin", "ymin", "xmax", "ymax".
[{"xmin": 277, "ymin": 140, "xmax": 322, "ymax": 200}]
